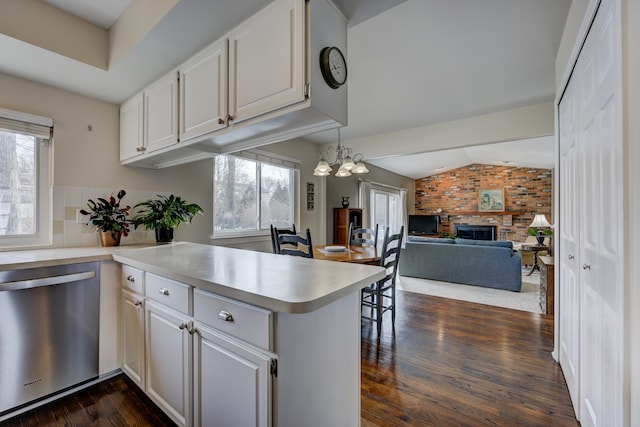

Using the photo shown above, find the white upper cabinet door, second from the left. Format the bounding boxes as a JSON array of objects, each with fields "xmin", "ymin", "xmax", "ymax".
[{"xmin": 144, "ymin": 71, "xmax": 178, "ymax": 152}]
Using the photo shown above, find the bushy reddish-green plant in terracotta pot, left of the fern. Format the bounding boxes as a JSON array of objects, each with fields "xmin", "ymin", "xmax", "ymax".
[{"xmin": 80, "ymin": 190, "xmax": 131, "ymax": 246}]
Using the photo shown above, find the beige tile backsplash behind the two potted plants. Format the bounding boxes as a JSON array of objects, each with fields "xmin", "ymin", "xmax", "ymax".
[{"xmin": 53, "ymin": 186, "xmax": 162, "ymax": 248}]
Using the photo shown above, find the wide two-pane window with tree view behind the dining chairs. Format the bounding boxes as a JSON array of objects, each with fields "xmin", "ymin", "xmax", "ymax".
[{"xmin": 213, "ymin": 156, "xmax": 295, "ymax": 237}]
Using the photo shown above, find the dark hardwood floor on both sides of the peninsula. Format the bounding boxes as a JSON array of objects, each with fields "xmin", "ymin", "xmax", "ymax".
[{"xmin": 2, "ymin": 291, "xmax": 579, "ymax": 427}]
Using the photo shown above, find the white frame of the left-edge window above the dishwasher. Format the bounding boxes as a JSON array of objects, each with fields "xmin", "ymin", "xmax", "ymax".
[{"xmin": 0, "ymin": 109, "xmax": 53, "ymax": 251}]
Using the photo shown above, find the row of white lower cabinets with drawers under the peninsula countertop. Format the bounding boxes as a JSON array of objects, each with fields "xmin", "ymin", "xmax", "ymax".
[{"xmin": 122, "ymin": 265, "xmax": 276, "ymax": 427}]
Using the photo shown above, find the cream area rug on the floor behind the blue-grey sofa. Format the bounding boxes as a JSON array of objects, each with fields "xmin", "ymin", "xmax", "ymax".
[{"xmin": 396, "ymin": 268, "xmax": 541, "ymax": 313}]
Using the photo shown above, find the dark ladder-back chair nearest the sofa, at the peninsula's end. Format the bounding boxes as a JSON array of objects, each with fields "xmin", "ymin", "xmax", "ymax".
[{"xmin": 361, "ymin": 226, "xmax": 404, "ymax": 335}]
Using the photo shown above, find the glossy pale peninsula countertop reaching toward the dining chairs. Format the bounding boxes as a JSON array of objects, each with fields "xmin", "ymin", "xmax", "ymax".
[{"xmin": 113, "ymin": 243, "xmax": 384, "ymax": 313}]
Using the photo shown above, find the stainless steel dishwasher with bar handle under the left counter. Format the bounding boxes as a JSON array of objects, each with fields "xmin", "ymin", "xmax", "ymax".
[{"xmin": 0, "ymin": 262, "xmax": 100, "ymax": 415}]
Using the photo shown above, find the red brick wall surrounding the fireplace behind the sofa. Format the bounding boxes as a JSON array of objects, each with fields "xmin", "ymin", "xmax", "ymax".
[{"xmin": 415, "ymin": 164, "xmax": 553, "ymax": 241}]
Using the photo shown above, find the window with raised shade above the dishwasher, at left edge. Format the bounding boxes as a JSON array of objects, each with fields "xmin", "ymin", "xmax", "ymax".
[{"xmin": 0, "ymin": 109, "xmax": 52, "ymax": 248}]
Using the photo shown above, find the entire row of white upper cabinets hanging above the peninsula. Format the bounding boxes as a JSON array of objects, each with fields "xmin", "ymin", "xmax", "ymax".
[{"xmin": 120, "ymin": 0, "xmax": 347, "ymax": 168}]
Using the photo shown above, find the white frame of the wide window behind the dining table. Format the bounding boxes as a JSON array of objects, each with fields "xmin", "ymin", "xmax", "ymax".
[{"xmin": 210, "ymin": 154, "xmax": 300, "ymax": 240}]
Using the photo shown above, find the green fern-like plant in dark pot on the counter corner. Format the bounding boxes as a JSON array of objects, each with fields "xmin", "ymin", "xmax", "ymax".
[{"xmin": 132, "ymin": 194, "xmax": 204, "ymax": 243}]
